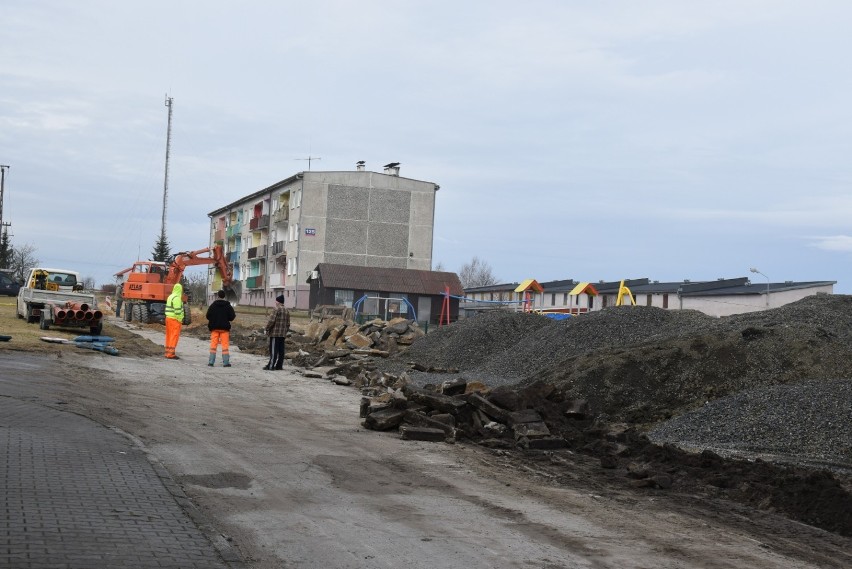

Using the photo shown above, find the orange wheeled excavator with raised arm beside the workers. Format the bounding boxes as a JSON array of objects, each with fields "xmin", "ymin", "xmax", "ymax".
[{"xmin": 122, "ymin": 245, "xmax": 240, "ymax": 324}]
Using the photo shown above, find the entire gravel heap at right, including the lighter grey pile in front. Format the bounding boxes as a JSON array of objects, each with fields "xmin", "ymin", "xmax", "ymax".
[{"xmin": 383, "ymin": 295, "xmax": 852, "ymax": 465}]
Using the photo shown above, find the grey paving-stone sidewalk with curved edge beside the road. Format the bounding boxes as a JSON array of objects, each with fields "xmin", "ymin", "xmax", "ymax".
[{"xmin": 0, "ymin": 396, "xmax": 235, "ymax": 569}]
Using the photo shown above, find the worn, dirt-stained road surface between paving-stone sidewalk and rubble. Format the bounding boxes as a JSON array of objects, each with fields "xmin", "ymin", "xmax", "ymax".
[{"xmin": 2, "ymin": 324, "xmax": 852, "ymax": 569}]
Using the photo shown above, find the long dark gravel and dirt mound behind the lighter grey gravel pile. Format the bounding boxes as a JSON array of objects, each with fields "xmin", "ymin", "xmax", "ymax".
[{"xmin": 379, "ymin": 295, "xmax": 852, "ymax": 423}]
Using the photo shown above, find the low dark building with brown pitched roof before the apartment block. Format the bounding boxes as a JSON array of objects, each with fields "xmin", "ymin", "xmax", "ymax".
[{"xmin": 308, "ymin": 263, "xmax": 464, "ymax": 324}]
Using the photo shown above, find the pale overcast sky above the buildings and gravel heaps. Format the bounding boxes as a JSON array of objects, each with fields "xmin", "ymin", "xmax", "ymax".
[{"xmin": 0, "ymin": 0, "xmax": 852, "ymax": 294}]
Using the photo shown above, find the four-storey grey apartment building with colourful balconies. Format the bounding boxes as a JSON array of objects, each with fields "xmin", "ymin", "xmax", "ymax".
[{"xmin": 208, "ymin": 162, "xmax": 439, "ymax": 309}]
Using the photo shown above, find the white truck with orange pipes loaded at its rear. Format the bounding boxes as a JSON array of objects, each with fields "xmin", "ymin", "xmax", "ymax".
[{"xmin": 17, "ymin": 267, "xmax": 103, "ymax": 336}]
